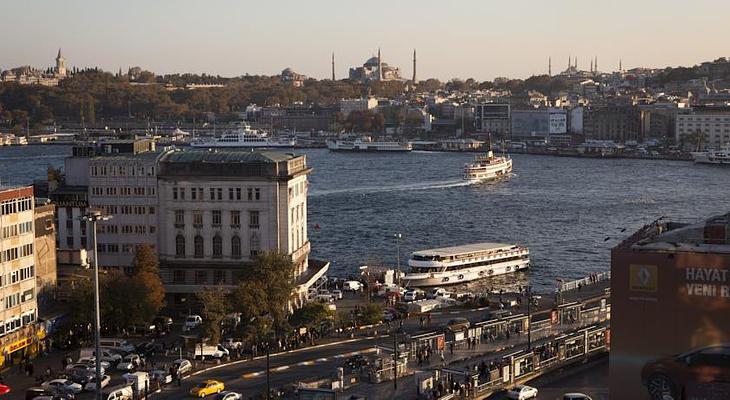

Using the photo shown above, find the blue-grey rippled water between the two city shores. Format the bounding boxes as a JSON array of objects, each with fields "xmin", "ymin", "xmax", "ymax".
[{"xmin": 0, "ymin": 146, "xmax": 730, "ymax": 289}]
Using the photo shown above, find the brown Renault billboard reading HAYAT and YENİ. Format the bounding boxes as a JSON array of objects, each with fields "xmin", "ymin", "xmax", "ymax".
[{"xmin": 610, "ymin": 246, "xmax": 730, "ymax": 400}]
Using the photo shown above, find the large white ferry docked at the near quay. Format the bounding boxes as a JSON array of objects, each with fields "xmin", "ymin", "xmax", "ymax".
[{"xmin": 403, "ymin": 243, "xmax": 530, "ymax": 287}]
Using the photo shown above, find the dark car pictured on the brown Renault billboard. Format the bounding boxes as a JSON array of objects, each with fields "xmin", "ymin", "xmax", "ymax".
[{"xmin": 641, "ymin": 344, "xmax": 730, "ymax": 400}]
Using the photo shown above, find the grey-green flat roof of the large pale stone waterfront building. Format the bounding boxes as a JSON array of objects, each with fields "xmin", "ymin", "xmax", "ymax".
[{"xmin": 160, "ymin": 149, "xmax": 297, "ymax": 164}]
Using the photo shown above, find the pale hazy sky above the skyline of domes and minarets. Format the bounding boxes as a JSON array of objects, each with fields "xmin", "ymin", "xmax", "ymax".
[{"xmin": 0, "ymin": 0, "xmax": 730, "ymax": 80}]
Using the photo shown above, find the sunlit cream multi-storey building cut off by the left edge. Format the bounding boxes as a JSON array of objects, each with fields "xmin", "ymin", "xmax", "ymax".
[{"xmin": 0, "ymin": 186, "xmax": 45, "ymax": 368}]
